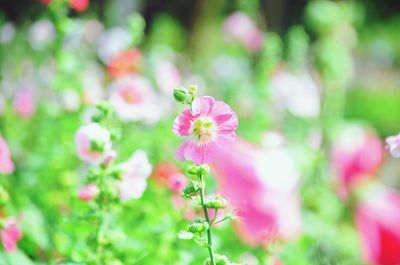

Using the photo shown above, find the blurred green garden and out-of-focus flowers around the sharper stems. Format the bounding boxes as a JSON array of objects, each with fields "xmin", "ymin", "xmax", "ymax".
[{"xmin": 0, "ymin": 0, "xmax": 400, "ymax": 265}]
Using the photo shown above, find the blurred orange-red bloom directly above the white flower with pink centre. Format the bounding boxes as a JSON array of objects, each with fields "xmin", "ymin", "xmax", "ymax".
[{"xmin": 107, "ymin": 49, "xmax": 142, "ymax": 79}]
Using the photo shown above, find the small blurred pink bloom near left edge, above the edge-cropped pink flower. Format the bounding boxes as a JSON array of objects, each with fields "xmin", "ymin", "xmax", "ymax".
[{"xmin": 14, "ymin": 88, "xmax": 36, "ymax": 118}]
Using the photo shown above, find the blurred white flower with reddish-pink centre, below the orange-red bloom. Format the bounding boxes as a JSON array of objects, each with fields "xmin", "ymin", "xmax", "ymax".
[{"xmin": 110, "ymin": 75, "xmax": 162, "ymax": 123}]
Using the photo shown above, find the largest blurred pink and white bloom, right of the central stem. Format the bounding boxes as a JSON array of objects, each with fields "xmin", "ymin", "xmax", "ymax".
[{"xmin": 210, "ymin": 141, "xmax": 302, "ymax": 245}]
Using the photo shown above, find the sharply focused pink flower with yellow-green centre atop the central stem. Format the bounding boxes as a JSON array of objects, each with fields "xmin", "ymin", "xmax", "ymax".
[{"xmin": 172, "ymin": 96, "xmax": 238, "ymax": 164}]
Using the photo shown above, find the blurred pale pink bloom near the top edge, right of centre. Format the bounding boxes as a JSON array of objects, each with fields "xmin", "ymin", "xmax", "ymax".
[{"xmin": 223, "ymin": 12, "xmax": 263, "ymax": 51}]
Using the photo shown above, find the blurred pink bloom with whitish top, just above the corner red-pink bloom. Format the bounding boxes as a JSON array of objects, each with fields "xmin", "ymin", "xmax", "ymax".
[{"xmin": 331, "ymin": 125, "xmax": 383, "ymax": 199}]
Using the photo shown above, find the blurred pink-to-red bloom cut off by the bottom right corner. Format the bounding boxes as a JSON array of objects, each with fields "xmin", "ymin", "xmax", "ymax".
[{"xmin": 356, "ymin": 185, "xmax": 400, "ymax": 265}]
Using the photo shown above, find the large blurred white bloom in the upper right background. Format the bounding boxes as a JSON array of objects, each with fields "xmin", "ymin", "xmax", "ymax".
[{"xmin": 268, "ymin": 70, "xmax": 321, "ymax": 118}]
